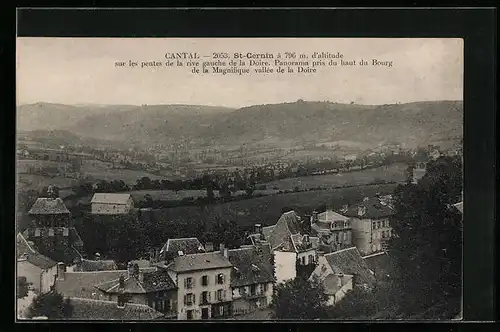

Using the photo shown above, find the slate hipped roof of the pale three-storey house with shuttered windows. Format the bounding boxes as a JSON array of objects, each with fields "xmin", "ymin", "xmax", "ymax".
[{"xmin": 168, "ymin": 252, "xmax": 233, "ymax": 273}]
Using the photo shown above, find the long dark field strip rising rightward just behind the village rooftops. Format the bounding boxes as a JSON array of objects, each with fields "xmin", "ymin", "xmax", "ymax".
[{"xmin": 148, "ymin": 184, "xmax": 396, "ymax": 232}]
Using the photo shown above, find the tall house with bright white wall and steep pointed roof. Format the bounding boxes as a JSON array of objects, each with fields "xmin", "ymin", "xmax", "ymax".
[{"xmin": 262, "ymin": 211, "xmax": 319, "ymax": 283}]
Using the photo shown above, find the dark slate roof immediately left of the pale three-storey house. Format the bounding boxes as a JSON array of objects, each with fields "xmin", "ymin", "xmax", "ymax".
[{"xmin": 96, "ymin": 271, "xmax": 176, "ymax": 294}]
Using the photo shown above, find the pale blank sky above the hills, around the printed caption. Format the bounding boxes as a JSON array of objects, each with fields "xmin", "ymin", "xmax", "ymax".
[{"xmin": 16, "ymin": 38, "xmax": 464, "ymax": 107}]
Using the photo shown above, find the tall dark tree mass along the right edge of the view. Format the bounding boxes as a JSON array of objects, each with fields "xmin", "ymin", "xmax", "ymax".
[{"xmin": 389, "ymin": 157, "xmax": 462, "ymax": 314}]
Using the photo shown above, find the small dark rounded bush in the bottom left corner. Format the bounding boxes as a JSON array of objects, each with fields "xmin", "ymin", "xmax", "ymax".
[{"xmin": 26, "ymin": 291, "xmax": 73, "ymax": 319}]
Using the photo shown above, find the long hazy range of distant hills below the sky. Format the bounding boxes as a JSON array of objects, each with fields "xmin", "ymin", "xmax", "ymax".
[{"xmin": 18, "ymin": 101, "xmax": 463, "ymax": 146}]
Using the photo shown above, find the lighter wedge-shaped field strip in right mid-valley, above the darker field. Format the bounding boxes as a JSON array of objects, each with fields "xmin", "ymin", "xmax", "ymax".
[{"xmin": 265, "ymin": 164, "xmax": 407, "ymax": 190}]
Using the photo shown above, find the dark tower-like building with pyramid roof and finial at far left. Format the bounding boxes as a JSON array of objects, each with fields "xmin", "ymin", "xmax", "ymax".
[{"xmin": 23, "ymin": 186, "xmax": 83, "ymax": 263}]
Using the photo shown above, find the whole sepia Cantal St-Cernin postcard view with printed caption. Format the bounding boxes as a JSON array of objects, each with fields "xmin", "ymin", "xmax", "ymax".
[{"xmin": 15, "ymin": 38, "xmax": 464, "ymax": 321}]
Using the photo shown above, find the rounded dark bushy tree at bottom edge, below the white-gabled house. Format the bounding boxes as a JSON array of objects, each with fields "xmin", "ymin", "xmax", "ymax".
[{"xmin": 271, "ymin": 278, "xmax": 328, "ymax": 320}]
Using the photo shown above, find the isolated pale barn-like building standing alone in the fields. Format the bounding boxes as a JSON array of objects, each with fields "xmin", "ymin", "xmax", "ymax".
[{"xmin": 90, "ymin": 193, "xmax": 134, "ymax": 215}]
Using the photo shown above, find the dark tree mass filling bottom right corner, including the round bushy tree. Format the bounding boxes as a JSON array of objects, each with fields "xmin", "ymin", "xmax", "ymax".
[{"xmin": 273, "ymin": 156, "xmax": 462, "ymax": 319}]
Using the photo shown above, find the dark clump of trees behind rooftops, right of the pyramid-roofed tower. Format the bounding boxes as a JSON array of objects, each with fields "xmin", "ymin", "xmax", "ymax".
[{"xmin": 75, "ymin": 211, "xmax": 245, "ymax": 262}]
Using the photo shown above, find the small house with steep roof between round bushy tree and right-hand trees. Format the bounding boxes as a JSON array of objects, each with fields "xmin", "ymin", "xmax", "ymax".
[{"xmin": 310, "ymin": 247, "xmax": 375, "ymax": 305}]
